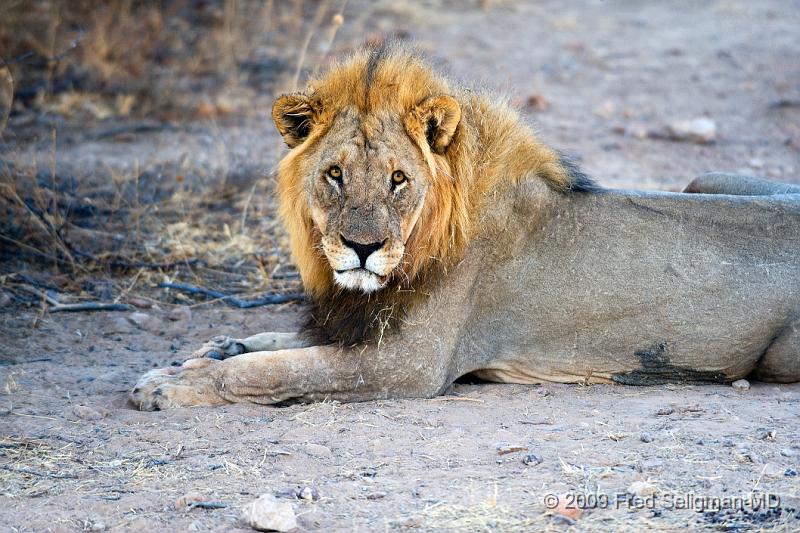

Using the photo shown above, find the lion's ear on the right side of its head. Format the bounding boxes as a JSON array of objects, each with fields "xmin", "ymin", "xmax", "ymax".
[{"xmin": 405, "ymin": 96, "xmax": 461, "ymax": 154}]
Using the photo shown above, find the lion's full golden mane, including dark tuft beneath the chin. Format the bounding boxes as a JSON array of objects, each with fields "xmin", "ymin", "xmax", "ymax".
[{"xmin": 277, "ymin": 46, "xmax": 590, "ymax": 343}]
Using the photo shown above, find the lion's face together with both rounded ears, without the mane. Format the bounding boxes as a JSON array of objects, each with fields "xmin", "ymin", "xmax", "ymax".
[{"xmin": 273, "ymin": 88, "xmax": 461, "ymax": 293}]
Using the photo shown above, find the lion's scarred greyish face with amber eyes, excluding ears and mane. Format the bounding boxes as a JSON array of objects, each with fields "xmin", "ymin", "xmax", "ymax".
[{"xmin": 304, "ymin": 110, "xmax": 430, "ymax": 292}]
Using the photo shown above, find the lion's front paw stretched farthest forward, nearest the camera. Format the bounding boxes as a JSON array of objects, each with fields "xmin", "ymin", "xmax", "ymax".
[{"xmin": 130, "ymin": 359, "xmax": 228, "ymax": 411}]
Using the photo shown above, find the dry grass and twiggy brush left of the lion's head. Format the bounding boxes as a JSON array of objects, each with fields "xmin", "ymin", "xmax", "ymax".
[{"xmin": 0, "ymin": 0, "xmax": 366, "ymax": 305}]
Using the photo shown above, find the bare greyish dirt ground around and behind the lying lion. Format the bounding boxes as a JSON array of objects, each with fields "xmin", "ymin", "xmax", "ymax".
[{"xmin": 0, "ymin": 0, "xmax": 800, "ymax": 531}]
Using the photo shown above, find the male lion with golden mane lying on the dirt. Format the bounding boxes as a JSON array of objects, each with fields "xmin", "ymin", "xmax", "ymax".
[{"xmin": 131, "ymin": 47, "xmax": 800, "ymax": 409}]
